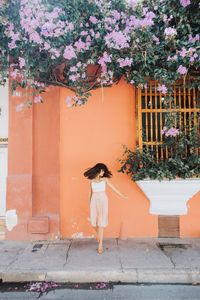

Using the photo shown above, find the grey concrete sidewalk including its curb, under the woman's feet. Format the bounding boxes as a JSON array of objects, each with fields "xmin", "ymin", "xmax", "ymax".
[{"xmin": 0, "ymin": 238, "xmax": 200, "ymax": 284}]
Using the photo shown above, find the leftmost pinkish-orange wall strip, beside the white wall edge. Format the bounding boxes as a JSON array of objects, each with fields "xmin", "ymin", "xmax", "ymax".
[{"xmin": 6, "ymin": 86, "xmax": 33, "ymax": 239}]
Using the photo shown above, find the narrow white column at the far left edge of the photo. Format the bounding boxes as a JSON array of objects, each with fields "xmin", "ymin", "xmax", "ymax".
[{"xmin": 0, "ymin": 84, "xmax": 8, "ymax": 218}]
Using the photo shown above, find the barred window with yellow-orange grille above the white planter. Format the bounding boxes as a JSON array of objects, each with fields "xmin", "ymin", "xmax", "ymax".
[{"xmin": 137, "ymin": 81, "xmax": 200, "ymax": 159}]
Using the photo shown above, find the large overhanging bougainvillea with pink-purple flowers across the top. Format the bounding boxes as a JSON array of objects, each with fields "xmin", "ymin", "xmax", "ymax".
[{"xmin": 0, "ymin": 0, "xmax": 200, "ymax": 106}]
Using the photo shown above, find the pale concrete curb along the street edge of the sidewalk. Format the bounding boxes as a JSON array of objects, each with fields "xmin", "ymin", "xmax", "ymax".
[{"xmin": 0, "ymin": 269, "xmax": 200, "ymax": 284}]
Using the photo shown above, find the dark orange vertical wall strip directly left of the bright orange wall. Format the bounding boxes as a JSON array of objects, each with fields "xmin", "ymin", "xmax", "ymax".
[{"xmin": 33, "ymin": 87, "xmax": 60, "ymax": 239}]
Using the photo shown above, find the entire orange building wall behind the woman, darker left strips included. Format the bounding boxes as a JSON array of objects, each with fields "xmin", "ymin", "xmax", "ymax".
[{"xmin": 7, "ymin": 81, "xmax": 200, "ymax": 239}]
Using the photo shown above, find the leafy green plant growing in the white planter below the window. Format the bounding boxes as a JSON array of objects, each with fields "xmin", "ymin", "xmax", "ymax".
[{"xmin": 119, "ymin": 127, "xmax": 200, "ymax": 181}]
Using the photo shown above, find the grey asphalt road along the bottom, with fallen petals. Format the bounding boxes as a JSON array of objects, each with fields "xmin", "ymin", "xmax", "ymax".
[{"xmin": 0, "ymin": 284, "xmax": 200, "ymax": 300}]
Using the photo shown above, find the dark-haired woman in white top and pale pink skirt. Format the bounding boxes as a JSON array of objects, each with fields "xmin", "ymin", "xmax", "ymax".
[{"xmin": 84, "ymin": 163, "xmax": 127, "ymax": 254}]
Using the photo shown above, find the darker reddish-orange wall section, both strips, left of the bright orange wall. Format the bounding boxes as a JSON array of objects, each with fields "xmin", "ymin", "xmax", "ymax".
[{"xmin": 6, "ymin": 88, "xmax": 60, "ymax": 240}]
